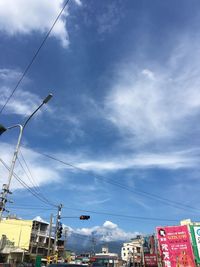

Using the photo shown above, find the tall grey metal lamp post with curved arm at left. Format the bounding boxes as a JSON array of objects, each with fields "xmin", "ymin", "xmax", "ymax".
[{"xmin": 0, "ymin": 94, "xmax": 53, "ymax": 221}]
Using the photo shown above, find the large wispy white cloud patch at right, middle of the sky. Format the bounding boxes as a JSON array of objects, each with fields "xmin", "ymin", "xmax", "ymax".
[{"xmin": 105, "ymin": 35, "xmax": 200, "ymax": 145}]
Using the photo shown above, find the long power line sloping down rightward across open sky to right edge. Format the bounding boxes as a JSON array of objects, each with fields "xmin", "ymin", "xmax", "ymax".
[{"xmin": 37, "ymin": 152, "xmax": 199, "ymax": 211}]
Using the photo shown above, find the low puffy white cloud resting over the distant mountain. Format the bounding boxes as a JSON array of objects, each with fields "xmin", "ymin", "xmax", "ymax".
[{"xmin": 72, "ymin": 221, "xmax": 139, "ymax": 242}]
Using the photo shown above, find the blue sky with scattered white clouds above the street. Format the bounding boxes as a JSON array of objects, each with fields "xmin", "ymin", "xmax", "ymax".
[{"xmin": 0, "ymin": 0, "xmax": 200, "ymax": 241}]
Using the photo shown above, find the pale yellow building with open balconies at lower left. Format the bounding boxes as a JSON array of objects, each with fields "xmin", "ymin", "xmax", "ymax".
[{"xmin": 0, "ymin": 217, "xmax": 64, "ymax": 263}]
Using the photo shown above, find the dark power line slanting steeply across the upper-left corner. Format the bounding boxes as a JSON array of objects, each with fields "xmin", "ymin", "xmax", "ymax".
[{"xmin": 0, "ymin": 0, "xmax": 70, "ymax": 114}]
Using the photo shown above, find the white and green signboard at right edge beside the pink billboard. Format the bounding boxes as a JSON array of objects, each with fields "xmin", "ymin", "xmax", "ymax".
[{"xmin": 190, "ymin": 225, "xmax": 200, "ymax": 263}]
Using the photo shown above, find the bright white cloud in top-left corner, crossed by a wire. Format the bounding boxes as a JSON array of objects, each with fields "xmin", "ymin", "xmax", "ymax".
[{"xmin": 0, "ymin": 0, "xmax": 81, "ymax": 47}]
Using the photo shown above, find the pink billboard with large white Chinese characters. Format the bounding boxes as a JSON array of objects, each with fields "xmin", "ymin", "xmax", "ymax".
[{"xmin": 156, "ymin": 225, "xmax": 196, "ymax": 267}]
